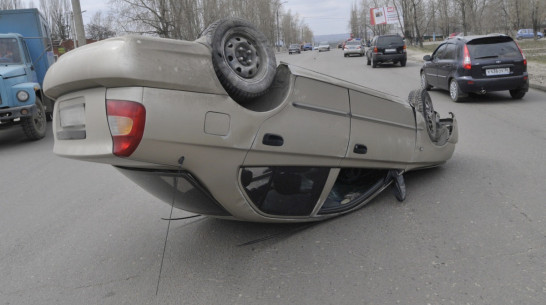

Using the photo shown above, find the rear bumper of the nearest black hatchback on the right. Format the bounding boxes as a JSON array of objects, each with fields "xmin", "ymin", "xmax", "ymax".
[{"xmin": 457, "ymin": 72, "xmax": 529, "ymax": 92}]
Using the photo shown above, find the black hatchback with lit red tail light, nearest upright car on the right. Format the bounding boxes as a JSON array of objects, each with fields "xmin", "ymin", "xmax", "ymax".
[{"xmin": 421, "ymin": 34, "xmax": 529, "ymax": 102}]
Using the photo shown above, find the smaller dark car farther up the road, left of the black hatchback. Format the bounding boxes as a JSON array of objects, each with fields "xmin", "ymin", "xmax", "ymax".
[{"xmin": 366, "ymin": 35, "xmax": 408, "ymax": 68}]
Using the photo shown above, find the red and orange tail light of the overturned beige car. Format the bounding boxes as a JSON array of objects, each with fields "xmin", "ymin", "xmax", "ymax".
[{"xmin": 106, "ymin": 100, "xmax": 146, "ymax": 157}]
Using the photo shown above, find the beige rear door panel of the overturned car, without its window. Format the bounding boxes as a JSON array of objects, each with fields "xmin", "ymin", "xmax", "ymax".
[{"xmin": 244, "ymin": 76, "xmax": 350, "ymax": 167}]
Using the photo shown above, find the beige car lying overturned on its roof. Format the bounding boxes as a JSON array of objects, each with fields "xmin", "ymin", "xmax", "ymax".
[{"xmin": 44, "ymin": 19, "xmax": 458, "ymax": 222}]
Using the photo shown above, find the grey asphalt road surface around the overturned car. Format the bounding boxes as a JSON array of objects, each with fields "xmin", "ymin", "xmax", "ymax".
[{"xmin": 0, "ymin": 50, "xmax": 546, "ymax": 305}]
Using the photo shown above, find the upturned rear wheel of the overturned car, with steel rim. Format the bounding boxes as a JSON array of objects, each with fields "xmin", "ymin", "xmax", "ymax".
[{"xmin": 199, "ymin": 18, "xmax": 277, "ymax": 102}]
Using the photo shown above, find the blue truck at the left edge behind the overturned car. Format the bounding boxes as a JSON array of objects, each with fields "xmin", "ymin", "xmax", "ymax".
[{"xmin": 0, "ymin": 8, "xmax": 55, "ymax": 140}]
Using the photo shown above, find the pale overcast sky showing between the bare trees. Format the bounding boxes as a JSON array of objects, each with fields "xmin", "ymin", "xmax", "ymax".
[{"xmin": 80, "ymin": 0, "xmax": 353, "ymax": 35}]
